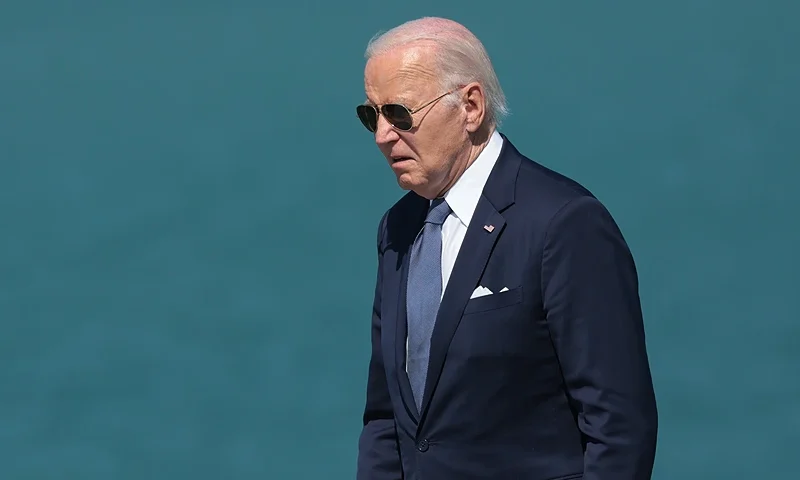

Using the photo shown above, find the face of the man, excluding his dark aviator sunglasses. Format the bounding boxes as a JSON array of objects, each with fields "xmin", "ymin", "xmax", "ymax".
[{"xmin": 364, "ymin": 45, "xmax": 469, "ymax": 199}]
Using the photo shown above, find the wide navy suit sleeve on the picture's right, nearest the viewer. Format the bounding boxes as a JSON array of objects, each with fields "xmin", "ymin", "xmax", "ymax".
[{"xmin": 542, "ymin": 197, "xmax": 658, "ymax": 480}]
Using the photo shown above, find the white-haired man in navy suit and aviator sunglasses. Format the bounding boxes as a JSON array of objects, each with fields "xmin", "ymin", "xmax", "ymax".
[{"xmin": 357, "ymin": 18, "xmax": 657, "ymax": 480}]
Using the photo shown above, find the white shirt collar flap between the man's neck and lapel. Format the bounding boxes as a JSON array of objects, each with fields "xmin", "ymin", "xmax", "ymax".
[{"xmin": 444, "ymin": 130, "xmax": 503, "ymax": 227}]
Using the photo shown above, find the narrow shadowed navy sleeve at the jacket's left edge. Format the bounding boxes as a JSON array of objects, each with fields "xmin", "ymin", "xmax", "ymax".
[{"xmin": 356, "ymin": 215, "xmax": 403, "ymax": 480}]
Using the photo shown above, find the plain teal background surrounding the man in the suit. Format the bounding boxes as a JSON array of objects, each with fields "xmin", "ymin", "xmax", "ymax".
[{"xmin": 0, "ymin": 0, "xmax": 800, "ymax": 480}]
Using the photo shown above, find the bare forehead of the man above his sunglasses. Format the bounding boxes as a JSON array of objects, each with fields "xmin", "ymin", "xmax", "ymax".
[{"xmin": 364, "ymin": 45, "xmax": 436, "ymax": 104}]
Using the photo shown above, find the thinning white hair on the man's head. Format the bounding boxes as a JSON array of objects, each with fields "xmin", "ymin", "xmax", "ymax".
[{"xmin": 364, "ymin": 17, "xmax": 510, "ymax": 126}]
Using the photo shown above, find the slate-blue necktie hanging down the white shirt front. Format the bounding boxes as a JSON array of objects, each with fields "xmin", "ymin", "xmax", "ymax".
[{"xmin": 406, "ymin": 198, "xmax": 450, "ymax": 411}]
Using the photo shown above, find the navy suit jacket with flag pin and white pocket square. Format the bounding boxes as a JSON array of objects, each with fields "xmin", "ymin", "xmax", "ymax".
[{"xmin": 357, "ymin": 136, "xmax": 657, "ymax": 480}]
